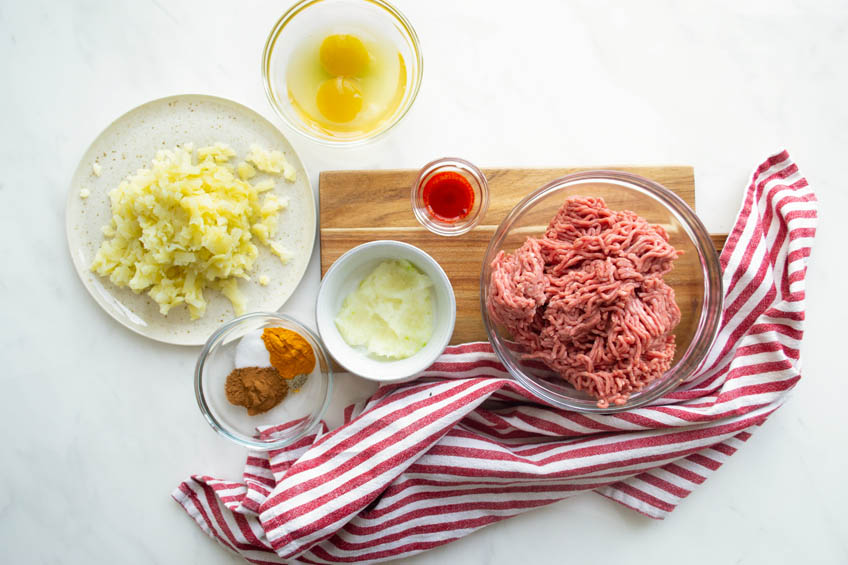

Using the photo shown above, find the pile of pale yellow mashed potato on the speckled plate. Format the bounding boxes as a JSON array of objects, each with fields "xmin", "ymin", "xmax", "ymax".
[{"xmin": 91, "ymin": 143, "xmax": 294, "ymax": 319}]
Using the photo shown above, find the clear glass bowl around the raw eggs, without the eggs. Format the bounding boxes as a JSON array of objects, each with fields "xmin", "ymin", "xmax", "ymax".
[{"xmin": 262, "ymin": 0, "xmax": 424, "ymax": 146}]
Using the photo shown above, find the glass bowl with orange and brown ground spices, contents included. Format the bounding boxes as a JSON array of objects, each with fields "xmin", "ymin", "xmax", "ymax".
[{"xmin": 194, "ymin": 312, "xmax": 333, "ymax": 450}]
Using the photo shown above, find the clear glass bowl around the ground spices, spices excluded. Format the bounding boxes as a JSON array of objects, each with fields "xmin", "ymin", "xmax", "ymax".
[{"xmin": 194, "ymin": 312, "xmax": 333, "ymax": 451}]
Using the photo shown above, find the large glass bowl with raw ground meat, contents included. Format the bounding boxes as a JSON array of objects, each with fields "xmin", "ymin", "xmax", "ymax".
[{"xmin": 481, "ymin": 171, "xmax": 723, "ymax": 413}]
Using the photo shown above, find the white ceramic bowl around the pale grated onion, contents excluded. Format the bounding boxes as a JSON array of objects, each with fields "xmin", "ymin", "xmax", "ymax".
[{"xmin": 315, "ymin": 240, "xmax": 456, "ymax": 383}]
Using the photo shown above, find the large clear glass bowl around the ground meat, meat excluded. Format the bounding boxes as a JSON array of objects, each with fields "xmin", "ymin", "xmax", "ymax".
[{"xmin": 480, "ymin": 171, "xmax": 723, "ymax": 413}]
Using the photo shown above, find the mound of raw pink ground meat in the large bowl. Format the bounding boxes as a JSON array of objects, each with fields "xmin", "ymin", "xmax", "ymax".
[{"xmin": 487, "ymin": 197, "xmax": 680, "ymax": 408}]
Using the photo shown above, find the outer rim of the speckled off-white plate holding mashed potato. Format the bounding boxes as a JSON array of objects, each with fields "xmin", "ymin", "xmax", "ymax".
[{"xmin": 65, "ymin": 93, "xmax": 317, "ymax": 346}]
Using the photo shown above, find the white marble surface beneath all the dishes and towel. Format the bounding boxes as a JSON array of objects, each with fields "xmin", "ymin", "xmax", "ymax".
[{"xmin": 0, "ymin": 0, "xmax": 848, "ymax": 564}]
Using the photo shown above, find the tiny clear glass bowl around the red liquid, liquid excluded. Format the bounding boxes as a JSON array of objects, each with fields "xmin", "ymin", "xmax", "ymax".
[{"xmin": 411, "ymin": 157, "xmax": 489, "ymax": 236}]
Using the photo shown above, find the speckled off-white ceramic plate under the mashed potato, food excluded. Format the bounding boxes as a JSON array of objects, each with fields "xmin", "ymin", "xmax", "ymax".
[{"xmin": 65, "ymin": 94, "xmax": 316, "ymax": 345}]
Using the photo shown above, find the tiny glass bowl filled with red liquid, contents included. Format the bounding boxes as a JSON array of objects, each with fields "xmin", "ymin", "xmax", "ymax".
[{"xmin": 411, "ymin": 157, "xmax": 489, "ymax": 236}]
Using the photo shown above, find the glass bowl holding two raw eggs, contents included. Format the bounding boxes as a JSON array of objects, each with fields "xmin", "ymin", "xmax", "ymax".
[{"xmin": 262, "ymin": 0, "xmax": 423, "ymax": 145}]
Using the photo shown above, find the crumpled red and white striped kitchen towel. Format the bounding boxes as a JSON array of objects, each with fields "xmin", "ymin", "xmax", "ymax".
[{"xmin": 173, "ymin": 152, "xmax": 817, "ymax": 563}]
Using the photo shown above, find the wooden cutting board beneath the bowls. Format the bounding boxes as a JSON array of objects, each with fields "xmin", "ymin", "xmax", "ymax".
[{"xmin": 319, "ymin": 167, "xmax": 726, "ymax": 343}]
